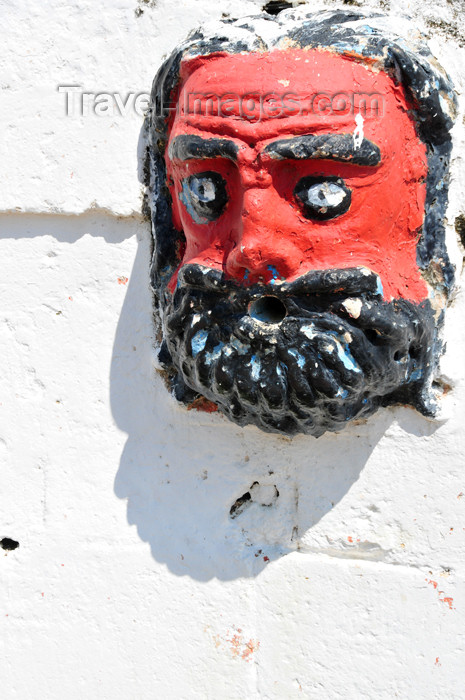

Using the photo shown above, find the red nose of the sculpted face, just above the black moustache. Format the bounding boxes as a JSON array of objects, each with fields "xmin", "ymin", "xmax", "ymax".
[{"xmin": 225, "ymin": 188, "xmax": 289, "ymax": 282}]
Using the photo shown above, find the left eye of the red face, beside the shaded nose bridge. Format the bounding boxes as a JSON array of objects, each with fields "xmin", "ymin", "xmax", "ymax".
[{"xmin": 179, "ymin": 172, "xmax": 228, "ymax": 224}]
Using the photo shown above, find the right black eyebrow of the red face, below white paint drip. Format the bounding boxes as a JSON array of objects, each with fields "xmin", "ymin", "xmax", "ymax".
[{"xmin": 264, "ymin": 134, "xmax": 381, "ymax": 165}]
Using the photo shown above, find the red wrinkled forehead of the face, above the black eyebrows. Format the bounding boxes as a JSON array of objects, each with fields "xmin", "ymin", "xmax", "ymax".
[{"xmin": 172, "ymin": 49, "xmax": 416, "ymax": 148}]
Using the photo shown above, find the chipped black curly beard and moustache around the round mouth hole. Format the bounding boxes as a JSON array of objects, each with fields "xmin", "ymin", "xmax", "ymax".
[{"xmin": 160, "ymin": 265, "xmax": 435, "ymax": 437}]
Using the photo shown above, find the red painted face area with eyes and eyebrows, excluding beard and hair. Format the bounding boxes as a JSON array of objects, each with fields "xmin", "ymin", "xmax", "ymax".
[{"xmin": 166, "ymin": 49, "xmax": 428, "ymax": 302}]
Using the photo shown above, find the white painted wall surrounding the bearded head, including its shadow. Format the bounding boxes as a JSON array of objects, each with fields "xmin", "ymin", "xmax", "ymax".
[{"xmin": 0, "ymin": 0, "xmax": 465, "ymax": 700}]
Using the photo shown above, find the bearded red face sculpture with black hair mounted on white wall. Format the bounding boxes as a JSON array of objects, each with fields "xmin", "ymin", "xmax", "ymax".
[{"xmin": 147, "ymin": 11, "xmax": 455, "ymax": 436}]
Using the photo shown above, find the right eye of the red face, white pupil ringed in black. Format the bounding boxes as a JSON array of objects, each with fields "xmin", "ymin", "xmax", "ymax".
[{"xmin": 294, "ymin": 175, "xmax": 351, "ymax": 221}]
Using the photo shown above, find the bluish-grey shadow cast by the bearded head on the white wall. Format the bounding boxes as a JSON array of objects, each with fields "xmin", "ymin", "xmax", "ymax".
[{"xmin": 111, "ymin": 227, "xmax": 437, "ymax": 581}]
